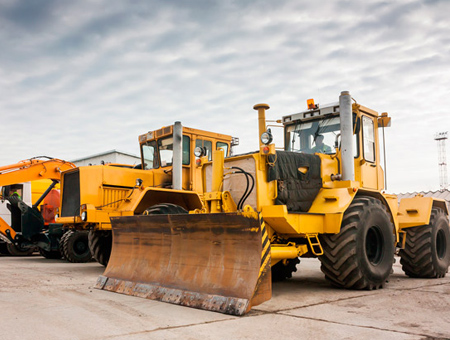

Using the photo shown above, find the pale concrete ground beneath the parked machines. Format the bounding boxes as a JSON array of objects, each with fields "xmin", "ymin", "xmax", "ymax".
[{"xmin": 0, "ymin": 255, "xmax": 450, "ymax": 340}]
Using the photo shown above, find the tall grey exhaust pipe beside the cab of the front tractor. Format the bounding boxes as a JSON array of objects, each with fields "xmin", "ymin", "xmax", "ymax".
[{"xmin": 339, "ymin": 91, "xmax": 355, "ymax": 181}]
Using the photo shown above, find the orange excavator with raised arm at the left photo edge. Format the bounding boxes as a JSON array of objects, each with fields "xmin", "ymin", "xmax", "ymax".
[{"xmin": 0, "ymin": 157, "xmax": 80, "ymax": 258}]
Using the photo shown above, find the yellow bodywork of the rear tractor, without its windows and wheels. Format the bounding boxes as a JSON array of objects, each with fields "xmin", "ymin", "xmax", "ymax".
[{"xmin": 56, "ymin": 125, "xmax": 232, "ymax": 230}]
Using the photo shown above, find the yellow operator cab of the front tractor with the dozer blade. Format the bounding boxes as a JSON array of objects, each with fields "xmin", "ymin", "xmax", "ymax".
[{"xmin": 282, "ymin": 100, "xmax": 391, "ymax": 190}]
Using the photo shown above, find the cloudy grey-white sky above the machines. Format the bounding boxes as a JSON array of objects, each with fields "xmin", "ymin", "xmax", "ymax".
[{"xmin": 0, "ymin": 0, "xmax": 450, "ymax": 193}]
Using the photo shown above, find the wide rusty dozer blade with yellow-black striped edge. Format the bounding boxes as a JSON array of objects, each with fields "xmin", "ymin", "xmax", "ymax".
[{"xmin": 96, "ymin": 213, "xmax": 272, "ymax": 315}]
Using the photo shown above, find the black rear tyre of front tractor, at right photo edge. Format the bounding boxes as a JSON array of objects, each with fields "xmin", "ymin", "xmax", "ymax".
[{"xmin": 399, "ymin": 208, "xmax": 450, "ymax": 278}]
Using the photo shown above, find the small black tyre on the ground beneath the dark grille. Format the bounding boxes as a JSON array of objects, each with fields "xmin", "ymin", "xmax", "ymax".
[{"xmin": 60, "ymin": 230, "xmax": 92, "ymax": 263}]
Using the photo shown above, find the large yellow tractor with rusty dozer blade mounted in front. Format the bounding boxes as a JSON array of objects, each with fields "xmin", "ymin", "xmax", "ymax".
[{"xmin": 96, "ymin": 91, "xmax": 450, "ymax": 315}]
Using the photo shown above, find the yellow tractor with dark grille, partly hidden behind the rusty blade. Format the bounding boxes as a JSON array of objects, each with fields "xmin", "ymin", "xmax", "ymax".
[{"xmin": 56, "ymin": 122, "xmax": 234, "ymax": 266}]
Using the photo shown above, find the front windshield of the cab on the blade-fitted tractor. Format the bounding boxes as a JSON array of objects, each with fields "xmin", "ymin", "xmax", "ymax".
[{"xmin": 286, "ymin": 117, "xmax": 341, "ymax": 154}]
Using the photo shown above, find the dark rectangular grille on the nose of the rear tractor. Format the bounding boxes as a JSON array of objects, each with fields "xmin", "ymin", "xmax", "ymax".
[{"xmin": 61, "ymin": 170, "xmax": 80, "ymax": 217}]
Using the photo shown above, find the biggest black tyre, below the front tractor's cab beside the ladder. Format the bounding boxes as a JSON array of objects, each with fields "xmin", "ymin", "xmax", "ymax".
[{"xmin": 319, "ymin": 196, "xmax": 395, "ymax": 290}]
